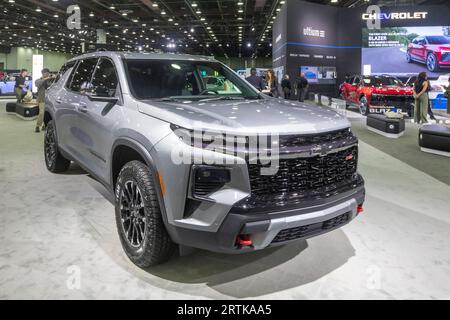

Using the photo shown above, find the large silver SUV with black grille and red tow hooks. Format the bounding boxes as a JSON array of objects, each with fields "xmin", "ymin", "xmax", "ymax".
[{"xmin": 45, "ymin": 52, "xmax": 365, "ymax": 267}]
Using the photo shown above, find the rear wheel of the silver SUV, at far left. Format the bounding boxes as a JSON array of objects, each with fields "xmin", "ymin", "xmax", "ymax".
[{"xmin": 44, "ymin": 120, "xmax": 70, "ymax": 173}]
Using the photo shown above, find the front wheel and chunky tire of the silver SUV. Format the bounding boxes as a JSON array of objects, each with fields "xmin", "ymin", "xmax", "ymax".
[{"xmin": 116, "ymin": 161, "xmax": 175, "ymax": 268}]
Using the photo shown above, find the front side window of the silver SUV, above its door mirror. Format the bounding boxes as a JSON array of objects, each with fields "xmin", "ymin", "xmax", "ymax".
[{"xmin": 92, "ymin": 58, "xmax": 119, "ymax": 97}]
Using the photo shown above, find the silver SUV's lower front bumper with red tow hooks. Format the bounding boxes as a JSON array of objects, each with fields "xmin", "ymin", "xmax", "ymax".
[{"xmin": 168, "ymin": 186, "xmax": 365, "ymax": 254}]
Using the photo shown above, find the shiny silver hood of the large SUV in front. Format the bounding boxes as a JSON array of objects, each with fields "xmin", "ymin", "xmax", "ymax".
[{"xmin": 139, "ymin": 98, "xmax": 350, "ymax": 135}]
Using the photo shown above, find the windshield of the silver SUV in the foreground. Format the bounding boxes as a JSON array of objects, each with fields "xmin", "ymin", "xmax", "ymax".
[{"xmin": 125, "ymin": 60, "xmax": 259, "ymax": 100}]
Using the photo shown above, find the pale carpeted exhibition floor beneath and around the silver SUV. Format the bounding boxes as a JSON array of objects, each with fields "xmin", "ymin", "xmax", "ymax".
[{"xmin": 0, "ymin": 102, "xmax": 450, "ymax": 299}]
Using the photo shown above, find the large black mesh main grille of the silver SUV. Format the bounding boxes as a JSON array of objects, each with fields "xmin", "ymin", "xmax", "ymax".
[{"xmin": 239, "ymin": 146, "xmax": 363, "ymax": 210}]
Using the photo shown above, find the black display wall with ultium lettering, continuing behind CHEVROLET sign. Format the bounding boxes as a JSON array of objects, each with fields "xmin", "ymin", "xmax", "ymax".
[{"xmin": 273, "ymin": 0, "xmax": 450, "ymax": 96}]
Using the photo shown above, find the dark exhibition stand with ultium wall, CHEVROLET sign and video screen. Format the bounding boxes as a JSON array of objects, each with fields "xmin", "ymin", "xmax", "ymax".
[{"xmin": 273, "ymin": 1, "xmax": 450, "ymax": 100}]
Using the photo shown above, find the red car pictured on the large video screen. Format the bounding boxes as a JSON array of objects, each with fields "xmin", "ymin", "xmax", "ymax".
[{"xmin": 406, "ymin": 36, "xmax": 450, "ymax": 72}]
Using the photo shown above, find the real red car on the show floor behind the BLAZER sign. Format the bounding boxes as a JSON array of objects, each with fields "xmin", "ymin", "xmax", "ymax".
[{"xmin": 340, "ymin": 75, "xmax": 414, "ymax": 117}]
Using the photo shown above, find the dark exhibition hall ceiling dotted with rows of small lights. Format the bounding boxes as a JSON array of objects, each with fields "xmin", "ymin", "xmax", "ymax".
[{"xmin": 0, "ymin": 0, "xmax": 448, "ymax": 57}]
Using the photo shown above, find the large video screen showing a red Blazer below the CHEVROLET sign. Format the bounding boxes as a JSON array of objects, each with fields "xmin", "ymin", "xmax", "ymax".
[{"xmin": 362, "ymin": 26, "xmax": 450, "ymax": 78}]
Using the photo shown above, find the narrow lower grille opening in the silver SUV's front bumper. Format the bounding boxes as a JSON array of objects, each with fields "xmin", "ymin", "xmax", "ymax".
[{"xmin": 272, "ymin": 213, "xmax": 351, "ymax": 243}]
